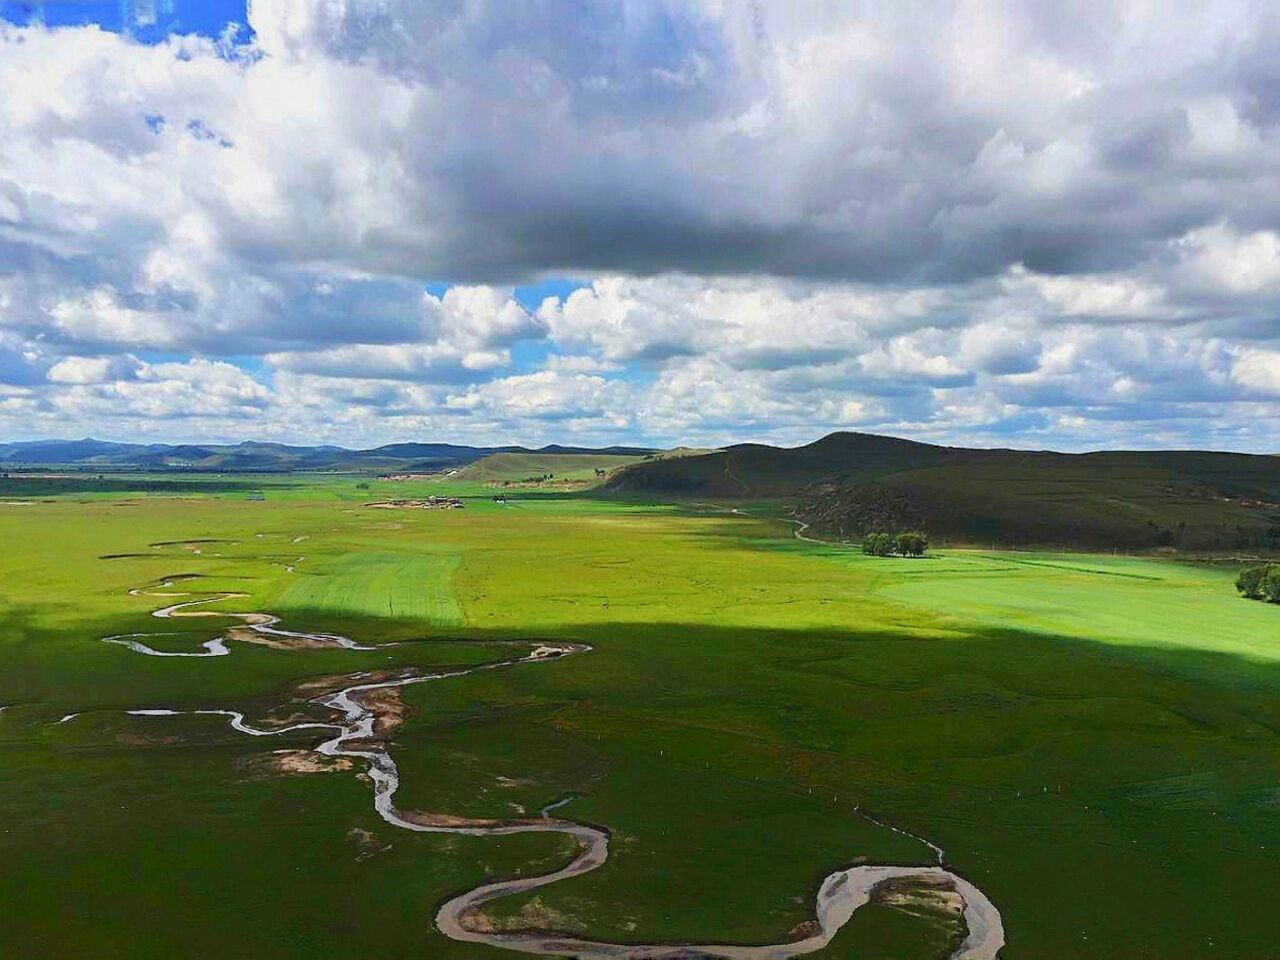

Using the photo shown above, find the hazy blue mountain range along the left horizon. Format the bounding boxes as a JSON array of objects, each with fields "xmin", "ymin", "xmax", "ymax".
[{"xmin": 0, "ymin": 438, "xmax": 654, "ymax": 472}]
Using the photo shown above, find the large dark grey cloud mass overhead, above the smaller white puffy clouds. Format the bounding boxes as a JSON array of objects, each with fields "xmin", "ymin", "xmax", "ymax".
[{"xmin": 227, "ymin": 3, "xmax": 1280, "ymax": 283}]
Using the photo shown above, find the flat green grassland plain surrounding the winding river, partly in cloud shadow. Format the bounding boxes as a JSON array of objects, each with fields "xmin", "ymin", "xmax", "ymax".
[{"xmin": 0, "ymin": 476, "xmax": 1280, "ymax": 960}]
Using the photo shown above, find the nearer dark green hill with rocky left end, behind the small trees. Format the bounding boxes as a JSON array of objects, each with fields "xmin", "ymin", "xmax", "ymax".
[{"xmin": 796, "ymin": 453, "xmax": 1280, "ymax": 552}]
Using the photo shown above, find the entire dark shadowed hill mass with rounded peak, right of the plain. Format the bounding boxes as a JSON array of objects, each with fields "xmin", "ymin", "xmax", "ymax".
[{"xmin": 604, "ymin": 433, "xmax": 1280, "ymax": 550}]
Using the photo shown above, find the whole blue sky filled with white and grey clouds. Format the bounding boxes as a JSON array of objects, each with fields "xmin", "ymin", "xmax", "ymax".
[{"xmin": 0, "ymin": 0, "xmax": 1280, "ymax": 453}]
